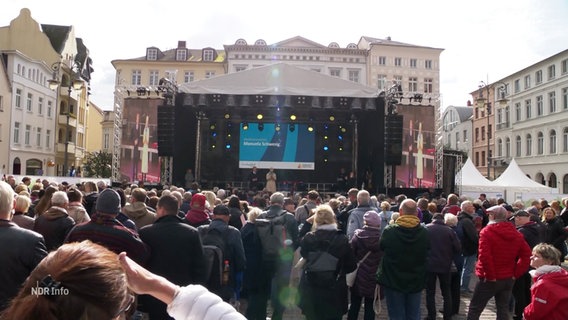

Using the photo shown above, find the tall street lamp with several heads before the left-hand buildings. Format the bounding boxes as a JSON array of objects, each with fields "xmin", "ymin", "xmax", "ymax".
[{"xmin": 48, "ymin": 61, "xmax": 83, "ymax": 176}]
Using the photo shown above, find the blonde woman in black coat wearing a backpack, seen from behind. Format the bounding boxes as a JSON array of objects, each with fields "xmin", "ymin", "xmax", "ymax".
[{"xmin": 299, "ymin": 205, "xmax": 357, "ymax": 320}]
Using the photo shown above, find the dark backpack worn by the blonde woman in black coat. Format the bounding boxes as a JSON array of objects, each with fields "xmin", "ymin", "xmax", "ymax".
[{"xmin": 304, "ymin": 236, "xmax": 339, "ymax": 289}]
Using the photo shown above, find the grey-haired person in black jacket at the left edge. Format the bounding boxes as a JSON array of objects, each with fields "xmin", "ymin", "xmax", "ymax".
[{"xmin": 0, "ymin": 181, "xmax": 47, "ymax": 311}]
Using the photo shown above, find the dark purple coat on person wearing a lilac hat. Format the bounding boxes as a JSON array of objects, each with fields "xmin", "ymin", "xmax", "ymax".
[{"xmin": 351, "ymin": 226, "xmax": 383, "ymax": 298}]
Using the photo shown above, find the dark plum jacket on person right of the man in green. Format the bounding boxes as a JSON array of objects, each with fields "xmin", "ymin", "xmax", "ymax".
[{"xmin": 426, "ymin": 219, "xmax": 461, "ymax": 273}]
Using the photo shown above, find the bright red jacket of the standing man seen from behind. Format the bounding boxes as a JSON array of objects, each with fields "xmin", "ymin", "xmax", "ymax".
[{"xmin": 475, "ymin": 221, "xmax": 531, "ymax": 280}]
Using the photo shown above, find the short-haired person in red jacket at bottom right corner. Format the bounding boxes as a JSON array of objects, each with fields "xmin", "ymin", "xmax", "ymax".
[{"xmin": 523, "ymin": 243, "xmax": 568, "ymax": 320}]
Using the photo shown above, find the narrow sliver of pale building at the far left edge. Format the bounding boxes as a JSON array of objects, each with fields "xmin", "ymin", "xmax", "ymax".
[{"xmin": 0, "ymin": 56, "xmax": 12, "ymax": 179}]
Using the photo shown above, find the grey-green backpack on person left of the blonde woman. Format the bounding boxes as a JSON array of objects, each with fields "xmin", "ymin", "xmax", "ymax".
[{"xmin": 254, "ymin": 210, "xmax": 286, "ymax": 262}]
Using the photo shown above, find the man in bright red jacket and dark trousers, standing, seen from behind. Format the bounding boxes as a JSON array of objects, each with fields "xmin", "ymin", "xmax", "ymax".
[{"xmin": 467, "ymin": 206, "xmax": 531, "ymax": 320}]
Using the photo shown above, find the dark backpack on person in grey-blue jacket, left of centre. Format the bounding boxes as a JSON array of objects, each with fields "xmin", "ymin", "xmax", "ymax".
[{"xmin": 199, "ymin": 225, "xmax": 232, "ymax": 301}]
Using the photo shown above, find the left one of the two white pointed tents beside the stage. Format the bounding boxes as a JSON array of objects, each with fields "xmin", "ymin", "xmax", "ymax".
[{"xmin": 455, "ymin": 158, "xmax": 505, "ymax": 198}]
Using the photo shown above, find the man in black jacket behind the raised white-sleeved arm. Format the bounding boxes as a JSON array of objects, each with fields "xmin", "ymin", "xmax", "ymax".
[{"xmin": 139, "ymin": 195, "xmax": 206, "ymax": 319}]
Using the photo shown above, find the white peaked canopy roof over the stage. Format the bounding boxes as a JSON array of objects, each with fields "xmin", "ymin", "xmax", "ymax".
[{"xmin": 179, "ymin": 63, "xmax": 378, "ymax": 98}]
